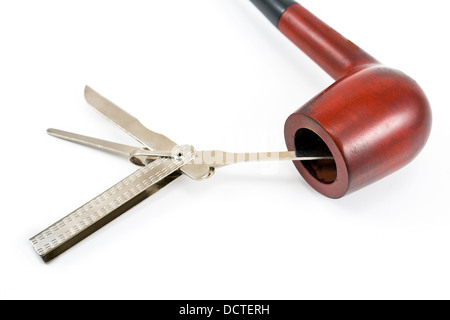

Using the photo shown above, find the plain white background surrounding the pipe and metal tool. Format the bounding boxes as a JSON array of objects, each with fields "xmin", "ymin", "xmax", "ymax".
[{"xmin": 0, "ymin": 0, "xmax": 450, "ymax": 299}]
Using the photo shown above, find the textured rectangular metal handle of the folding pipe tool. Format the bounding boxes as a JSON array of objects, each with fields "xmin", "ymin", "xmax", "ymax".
[{"xmin": 30, "ymin": 148, "xmax": 195, "ymax": 262}]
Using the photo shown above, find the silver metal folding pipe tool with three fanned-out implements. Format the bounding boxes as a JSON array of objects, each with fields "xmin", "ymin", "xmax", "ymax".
[{"xmin": 30, "ymin": 87, "xmax": 330, "ymax": 262}]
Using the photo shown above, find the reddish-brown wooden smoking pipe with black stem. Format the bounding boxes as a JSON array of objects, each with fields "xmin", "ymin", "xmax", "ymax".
[{"xmin": 250, "ymin": 0, "xmax": 431, "ymax": 198}]
